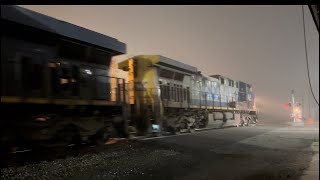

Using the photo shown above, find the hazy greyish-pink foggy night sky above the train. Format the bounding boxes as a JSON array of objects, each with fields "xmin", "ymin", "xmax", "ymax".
[{"xmin": 23, "ymin": 5, "xmax": 319, "ymax": 123}]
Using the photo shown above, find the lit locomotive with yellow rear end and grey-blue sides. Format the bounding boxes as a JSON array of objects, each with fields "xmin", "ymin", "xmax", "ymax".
[{"xmin": 118, "ymin": 55, "xmax": 258, "ymax": 133}]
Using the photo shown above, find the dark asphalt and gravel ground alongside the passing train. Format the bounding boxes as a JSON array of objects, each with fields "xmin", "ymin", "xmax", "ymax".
[{"xmin": 1, "ymin": 126, "xmax": 319, "ymax": 180}]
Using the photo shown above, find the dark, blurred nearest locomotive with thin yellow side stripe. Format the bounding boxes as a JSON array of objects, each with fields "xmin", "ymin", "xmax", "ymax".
[{"xmin": 0, "ymin": 6, "xmax": 126, "ymax": 149}]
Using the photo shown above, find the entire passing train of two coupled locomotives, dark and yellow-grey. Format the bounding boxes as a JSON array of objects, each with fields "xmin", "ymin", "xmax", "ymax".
[{"xmin": 0, "ymin": 6, "xmax": 257, "ymax": 152}]
